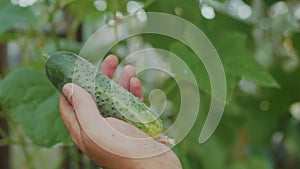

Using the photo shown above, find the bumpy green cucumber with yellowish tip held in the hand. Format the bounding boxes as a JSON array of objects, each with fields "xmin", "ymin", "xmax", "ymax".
[{"xmin": 45, "ymin": 51, "xmax": 163, "ymax": 137}]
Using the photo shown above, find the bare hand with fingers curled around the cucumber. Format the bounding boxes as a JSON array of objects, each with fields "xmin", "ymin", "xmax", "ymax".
[{"xmin": 60, "ymin": 55, "xmax": 182, "ymax": 169}]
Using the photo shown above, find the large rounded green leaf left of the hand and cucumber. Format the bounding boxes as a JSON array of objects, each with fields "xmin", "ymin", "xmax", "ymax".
[{"xmin": 0, "ymin": 67, "xmax": 71, "ymax": 147}]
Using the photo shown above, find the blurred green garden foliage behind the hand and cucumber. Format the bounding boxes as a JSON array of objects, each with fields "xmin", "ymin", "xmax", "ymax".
[{"xmin": 0, "ymin": 0, "xmax": 300, "ymax": 169}]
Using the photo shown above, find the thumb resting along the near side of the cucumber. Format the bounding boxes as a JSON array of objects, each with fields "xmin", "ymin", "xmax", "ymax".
[{"xmin": 63, "ymin": 83, "xmax": 129, "ymax": 154}]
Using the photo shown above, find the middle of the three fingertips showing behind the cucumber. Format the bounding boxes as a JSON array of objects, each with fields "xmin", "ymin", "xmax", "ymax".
[{"xmin": 118, "ymin": 65, "xmax": 135, "ymax": 90}]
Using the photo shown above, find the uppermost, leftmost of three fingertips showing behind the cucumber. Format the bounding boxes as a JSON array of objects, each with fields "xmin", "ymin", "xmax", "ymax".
[{"xmin": 100, "ymin": 55, "xmax": 118, "ymax": 78}]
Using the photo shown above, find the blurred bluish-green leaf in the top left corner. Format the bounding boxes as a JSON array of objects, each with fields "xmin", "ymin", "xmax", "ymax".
[{"xmin": 0, "ymin": 1, "xmax": 37, "ymax": 34}]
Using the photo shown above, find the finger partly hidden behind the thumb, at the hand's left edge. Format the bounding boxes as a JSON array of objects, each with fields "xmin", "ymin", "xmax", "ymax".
[{"xmin": 59, "ymin": 96, "xmax": 84, "ymax": 148}]
